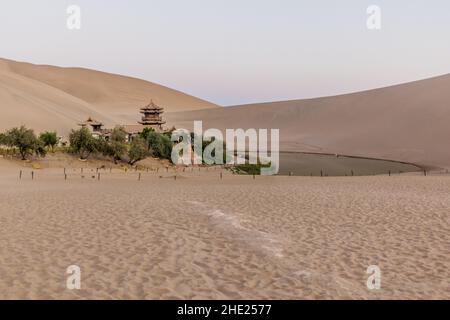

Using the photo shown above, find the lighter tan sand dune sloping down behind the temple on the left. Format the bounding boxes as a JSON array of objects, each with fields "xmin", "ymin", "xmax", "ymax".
[{"xmin": 0, "ymin": 59, "xmax": 217, "ymax": 134}]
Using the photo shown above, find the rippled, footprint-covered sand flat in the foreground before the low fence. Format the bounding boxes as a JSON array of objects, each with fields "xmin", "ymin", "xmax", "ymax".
[{"xmin": 0, "ymin": 166, "xmax": 450, "ymax": 299}]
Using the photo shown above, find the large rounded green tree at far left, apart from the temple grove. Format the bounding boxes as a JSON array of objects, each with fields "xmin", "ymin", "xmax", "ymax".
[{"xmin": 3, "ymin": 126, "xmax": 45, "ymax": 160}]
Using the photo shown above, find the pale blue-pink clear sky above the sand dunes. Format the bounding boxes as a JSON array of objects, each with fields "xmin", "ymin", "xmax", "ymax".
[{"xmin": 0, "ymin": 0, "xmax": 450, "ymax": 105}]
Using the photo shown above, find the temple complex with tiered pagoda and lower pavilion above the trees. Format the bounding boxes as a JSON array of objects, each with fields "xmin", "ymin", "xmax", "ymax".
[{"xmin": 79, "ymin": 101, "xmax": 166, "ymax": 142}]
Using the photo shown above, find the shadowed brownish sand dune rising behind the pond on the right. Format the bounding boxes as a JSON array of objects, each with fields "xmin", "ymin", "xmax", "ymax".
[{"xmin": 167, "ymin": 75, "xmax": 450, "ymax": 167}]
